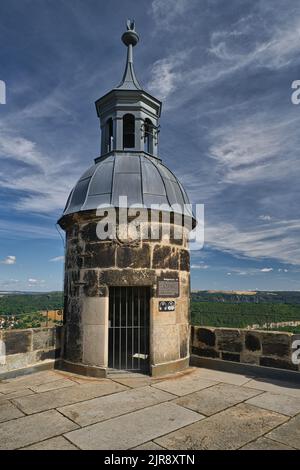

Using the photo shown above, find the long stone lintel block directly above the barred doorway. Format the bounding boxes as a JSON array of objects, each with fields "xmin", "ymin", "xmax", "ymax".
[{"xmin": 99, "ymin": 268, "xmax": 156, "ymax": 286}]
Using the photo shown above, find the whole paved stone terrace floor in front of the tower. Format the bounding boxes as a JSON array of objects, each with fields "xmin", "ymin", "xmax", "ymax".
[{"xmin": 0, "ymin": 368, "xmax": 300, "ymax": 450}]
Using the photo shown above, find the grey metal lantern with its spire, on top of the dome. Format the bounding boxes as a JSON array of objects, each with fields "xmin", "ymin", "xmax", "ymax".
[{"xmin": 96, "ymin": 21, "xmax": 161, "ymax": 156}]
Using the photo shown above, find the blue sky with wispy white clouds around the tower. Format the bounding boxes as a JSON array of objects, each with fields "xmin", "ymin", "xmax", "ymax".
[{"xmin": 0, "ymin": 0, "xmax": 300, "ymax": 291}]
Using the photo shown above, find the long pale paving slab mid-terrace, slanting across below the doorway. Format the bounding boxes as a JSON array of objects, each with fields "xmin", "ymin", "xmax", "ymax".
[{"xmin": 58, "ymin": 387, "xmax": 174, "ymax": 426}]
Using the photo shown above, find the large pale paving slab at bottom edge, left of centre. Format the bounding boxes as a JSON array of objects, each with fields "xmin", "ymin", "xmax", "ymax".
[{"xmin": 66, "ymin": 403, "xmax": 203, "ymax": 450}]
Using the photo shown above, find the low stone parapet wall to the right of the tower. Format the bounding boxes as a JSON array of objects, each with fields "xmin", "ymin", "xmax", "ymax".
[{"xmin": 191, "ymin": 326, "xmax": 300, "ymax": 371}]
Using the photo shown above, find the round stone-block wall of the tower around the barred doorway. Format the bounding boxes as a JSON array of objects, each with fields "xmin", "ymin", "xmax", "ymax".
[{"xmin": 63, "ymin": 213, "xmax": 190, "ymax": 373}]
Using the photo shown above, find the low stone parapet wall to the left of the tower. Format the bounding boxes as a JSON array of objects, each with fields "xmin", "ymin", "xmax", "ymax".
[{"xmin": 0, "ymin": 326, "xmax": 62, "ymax": 377}]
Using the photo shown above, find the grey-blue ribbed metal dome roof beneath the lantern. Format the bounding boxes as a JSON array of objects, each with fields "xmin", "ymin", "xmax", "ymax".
[{"xmin": 63, "ymin": 154, "xmax": 193, "ymax": 217}]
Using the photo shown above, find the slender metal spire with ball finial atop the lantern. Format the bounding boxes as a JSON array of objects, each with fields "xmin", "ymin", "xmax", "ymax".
[{"xmin": 117, "ymin": 20, "xmax": 142, "ymax": 90}]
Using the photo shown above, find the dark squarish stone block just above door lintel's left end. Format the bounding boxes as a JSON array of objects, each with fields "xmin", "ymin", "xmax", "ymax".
[{"xmin": 84, "ymin": 242, "xmax": 116, "ymax": 268}]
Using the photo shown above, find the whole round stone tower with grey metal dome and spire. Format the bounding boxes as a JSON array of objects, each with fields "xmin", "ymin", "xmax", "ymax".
[{"xmin": 58, "ymin": 21, "xmax": 195, "ymax": 377}]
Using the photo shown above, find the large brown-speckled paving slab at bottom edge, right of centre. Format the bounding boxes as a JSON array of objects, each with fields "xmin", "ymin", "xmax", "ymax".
[{"xmin": 154, "ymin": 404, "xmax": 288, "ymax": 450}]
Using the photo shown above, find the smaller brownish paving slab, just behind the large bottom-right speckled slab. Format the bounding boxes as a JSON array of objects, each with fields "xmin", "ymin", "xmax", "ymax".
[{"xmin": 175, "ymin": 384, "xmax": 263, "ymax": 416}]
